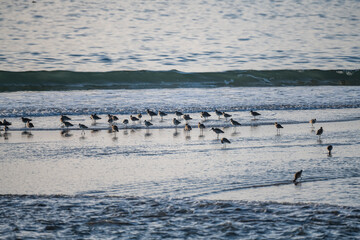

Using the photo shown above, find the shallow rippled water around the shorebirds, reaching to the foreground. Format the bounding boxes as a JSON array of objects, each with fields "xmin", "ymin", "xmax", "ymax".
[{"xmin": 0, "ymin": 108, "xmax": 360, "ymax": 239}]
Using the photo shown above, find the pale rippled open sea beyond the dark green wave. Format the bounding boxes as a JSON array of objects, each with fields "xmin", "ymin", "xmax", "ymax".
[{"xmin": 0, "ymin": 0, "xmax": 360, "ymax": 72}]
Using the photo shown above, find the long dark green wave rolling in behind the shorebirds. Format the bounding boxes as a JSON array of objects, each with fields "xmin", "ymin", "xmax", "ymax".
[{"xmin": 0, "ymin": 70, "xmax": 360, "ymax": 92}]
